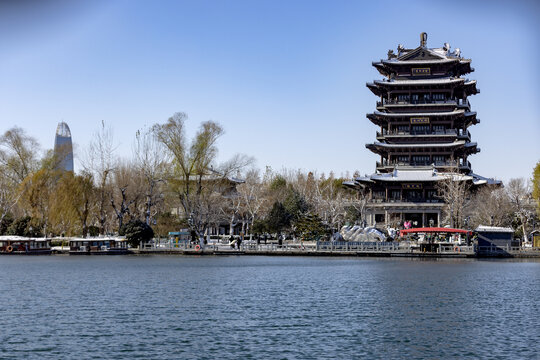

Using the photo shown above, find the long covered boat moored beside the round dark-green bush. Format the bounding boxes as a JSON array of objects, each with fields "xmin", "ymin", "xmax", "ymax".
[{"xmin": 69, "ymin": 238, "xmax": 129, "ymax": 255}]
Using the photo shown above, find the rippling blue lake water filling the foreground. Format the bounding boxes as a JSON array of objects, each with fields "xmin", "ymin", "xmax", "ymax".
[{"xmin": 0, "ymin": 256, "xmax": 540, "ymax": 359}]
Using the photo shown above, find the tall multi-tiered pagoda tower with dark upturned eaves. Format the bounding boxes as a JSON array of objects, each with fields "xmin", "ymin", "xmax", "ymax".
[{"xmin": 346, "ymin": 33, "xmax": 496, "ymax": 227}]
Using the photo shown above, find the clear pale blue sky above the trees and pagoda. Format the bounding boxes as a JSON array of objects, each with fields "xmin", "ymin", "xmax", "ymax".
[{"xmin": 0, "ymin": 0, "xmax": 540, "ymax": 181}]
